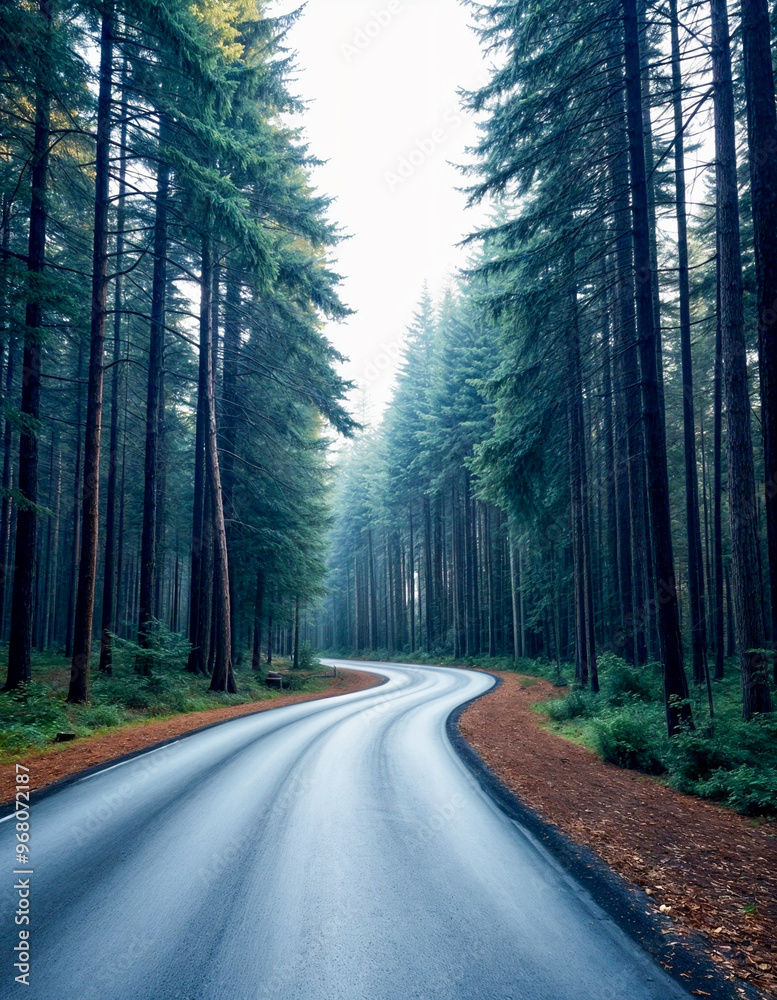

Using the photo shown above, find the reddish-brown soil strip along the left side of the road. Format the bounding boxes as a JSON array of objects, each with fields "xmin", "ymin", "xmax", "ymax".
[{"xmin": 0, "ymin": 670, "xmax": 382, "ymax": 804}]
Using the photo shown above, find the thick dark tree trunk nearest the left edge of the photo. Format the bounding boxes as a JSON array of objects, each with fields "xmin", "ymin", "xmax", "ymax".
[{"xmin": 3, "ymin": 0, "xmax": 51, "ymax": 691}]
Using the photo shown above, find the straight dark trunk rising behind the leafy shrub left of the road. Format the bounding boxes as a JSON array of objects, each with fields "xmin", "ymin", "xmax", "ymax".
[{"xmin": 137, "ymin": 145, "xmax": 170, "ymax": 674}]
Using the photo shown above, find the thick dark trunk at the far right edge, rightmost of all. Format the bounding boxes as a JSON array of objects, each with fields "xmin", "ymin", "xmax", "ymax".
[{"xmin": 742, "ymin": 0, "xmax": 777, "ymax": 664}]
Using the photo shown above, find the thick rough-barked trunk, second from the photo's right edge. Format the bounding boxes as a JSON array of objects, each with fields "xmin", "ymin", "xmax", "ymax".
[{"xmin": 710, "ymin": 0, "xmax": 771, "ymax": 719}]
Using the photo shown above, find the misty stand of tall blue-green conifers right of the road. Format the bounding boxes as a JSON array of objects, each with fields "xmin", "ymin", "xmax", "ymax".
[{"xmin": 316, "ymin": 0, "xmax": 777, "ymax": 735}]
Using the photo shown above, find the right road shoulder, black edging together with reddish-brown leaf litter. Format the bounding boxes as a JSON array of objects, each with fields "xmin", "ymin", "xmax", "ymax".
[{"xmin": 448, "ymin": 672, "xmax": 777, "ymax": 1000}]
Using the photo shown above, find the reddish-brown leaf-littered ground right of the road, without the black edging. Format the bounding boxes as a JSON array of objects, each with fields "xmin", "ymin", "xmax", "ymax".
[{"xmin": 459, "ymin": 671, "xmax": 777, "ymax": 995}]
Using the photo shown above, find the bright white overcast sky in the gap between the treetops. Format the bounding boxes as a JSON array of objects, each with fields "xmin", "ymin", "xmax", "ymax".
[{"xmin": 271, "ymin": 0, "xmax": 492, "ymax": 419}]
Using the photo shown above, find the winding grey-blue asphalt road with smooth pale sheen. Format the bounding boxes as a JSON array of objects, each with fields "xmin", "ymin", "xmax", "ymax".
[{"xmin": 0, "ymin": 664, "xmax": 688, "ymax": 1000}]
